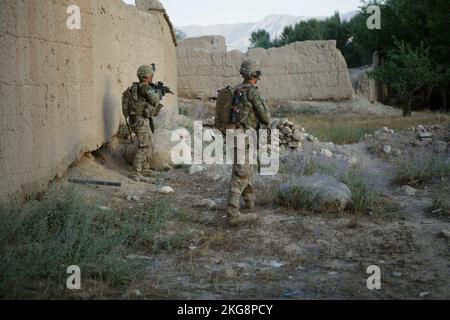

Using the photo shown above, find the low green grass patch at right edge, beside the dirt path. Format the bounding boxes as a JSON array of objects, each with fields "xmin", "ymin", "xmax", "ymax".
[{"xmin": 394, "ymin": 156, "xmax": 450, "ymax": 185}]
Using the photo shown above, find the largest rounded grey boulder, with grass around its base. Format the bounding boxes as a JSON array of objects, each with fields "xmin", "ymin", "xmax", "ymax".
[{"xmin": 280, "ymin": 174, "xmax": 352, "ymax": 211}]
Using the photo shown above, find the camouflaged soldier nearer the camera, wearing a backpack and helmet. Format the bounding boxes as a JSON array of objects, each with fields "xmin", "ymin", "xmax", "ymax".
[{"xmin": 227, "ymin": 60, "xmax": 270, "ymax": 226}]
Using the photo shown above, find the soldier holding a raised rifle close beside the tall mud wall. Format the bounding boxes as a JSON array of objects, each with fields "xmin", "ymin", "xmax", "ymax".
[{"xmin": 123, "ymin": 64, "xmax": 165, "ymax": 182}]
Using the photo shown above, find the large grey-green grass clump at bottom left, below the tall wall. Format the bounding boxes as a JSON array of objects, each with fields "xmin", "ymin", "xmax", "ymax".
[{"xmin": 0, "ymin": 189, "xmax": 171, "ymax": 299}]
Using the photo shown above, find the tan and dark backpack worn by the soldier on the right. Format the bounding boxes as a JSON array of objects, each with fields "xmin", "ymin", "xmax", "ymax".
[{"xmin": 215, "ymin": 87, "xmax": 245, "ymax": 134}]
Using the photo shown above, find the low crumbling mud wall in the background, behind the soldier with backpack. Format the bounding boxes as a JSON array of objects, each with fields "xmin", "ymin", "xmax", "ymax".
[{"xmin": 177, "ymin": 36, "xmax": 353, "ymax": 100}]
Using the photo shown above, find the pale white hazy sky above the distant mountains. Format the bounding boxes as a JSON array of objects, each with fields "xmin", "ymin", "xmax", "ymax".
[{"xmin": 124, "ymin": 0, "xmax": 361, "ymax": 26}]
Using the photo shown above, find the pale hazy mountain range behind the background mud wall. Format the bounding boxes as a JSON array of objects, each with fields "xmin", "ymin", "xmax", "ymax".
[{"xmin": 178, "ymin": 11, "xmax": 358, "ymax": 52}]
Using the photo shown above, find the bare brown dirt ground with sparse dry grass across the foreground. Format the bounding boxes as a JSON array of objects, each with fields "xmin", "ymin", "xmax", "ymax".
[{"xmin": 50, "ymin": 112, "xmax": 450, "ymax": 299}]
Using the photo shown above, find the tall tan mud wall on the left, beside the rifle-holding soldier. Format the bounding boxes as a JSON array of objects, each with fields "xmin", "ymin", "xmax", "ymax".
[{"xmin": 0, "ymin": 0, "xmax": 178, "ymax": 208}]
